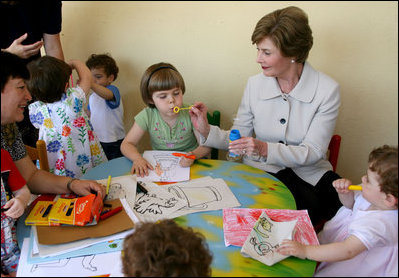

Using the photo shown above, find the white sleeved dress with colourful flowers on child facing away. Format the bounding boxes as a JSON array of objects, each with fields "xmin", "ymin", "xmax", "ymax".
[{"xmin": 29, "ymin": 86, "xmax": 107, "ymax": 178}]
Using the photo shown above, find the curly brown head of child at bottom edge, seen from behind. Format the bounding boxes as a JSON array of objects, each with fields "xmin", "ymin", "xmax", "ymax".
[{"xmin": 122, "ymin": 219, "xmax": 212, "ymax": 277}]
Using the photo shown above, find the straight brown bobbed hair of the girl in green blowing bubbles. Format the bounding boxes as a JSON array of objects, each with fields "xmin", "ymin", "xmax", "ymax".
[{"xmin": 140, "ymin": 63, "xmax": 186, "ymax": 108}]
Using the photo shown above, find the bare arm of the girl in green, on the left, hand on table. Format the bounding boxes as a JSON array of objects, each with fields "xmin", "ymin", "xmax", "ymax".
[{"xmin": 121, "ymin": 123, "xmax": 154, "ymax": 177}]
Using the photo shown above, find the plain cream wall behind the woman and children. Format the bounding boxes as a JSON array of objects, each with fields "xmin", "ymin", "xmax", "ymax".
[{"xmin": 61, "ymin": 1, "xmax": 398, "ymax": 183}]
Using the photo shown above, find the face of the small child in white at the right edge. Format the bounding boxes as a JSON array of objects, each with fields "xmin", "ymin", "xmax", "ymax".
[{"xmin": 362, "ymin": 169, "xmax": 386, "ymax": 209}]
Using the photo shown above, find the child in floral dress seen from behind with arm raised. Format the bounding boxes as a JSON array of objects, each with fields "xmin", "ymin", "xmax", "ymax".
[{"xmin": 27, "ymin": 56, "xmax": 107, "ymax": 178}]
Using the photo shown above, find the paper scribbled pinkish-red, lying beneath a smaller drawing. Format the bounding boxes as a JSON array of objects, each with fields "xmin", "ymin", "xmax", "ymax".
[{"xmin": 223, "ymin": 208, "xmax": 319, "ymax": 247}]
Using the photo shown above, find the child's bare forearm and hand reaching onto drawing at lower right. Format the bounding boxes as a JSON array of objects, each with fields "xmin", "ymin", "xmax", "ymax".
[{"xmin": 276, "ymin": 235, "xmax": 367, "ymax": 262}]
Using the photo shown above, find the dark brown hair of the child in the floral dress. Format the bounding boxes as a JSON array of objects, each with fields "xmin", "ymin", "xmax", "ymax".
[{"xmin": 27, "ymin": 56, "xmax": 72, "ymax": 103}]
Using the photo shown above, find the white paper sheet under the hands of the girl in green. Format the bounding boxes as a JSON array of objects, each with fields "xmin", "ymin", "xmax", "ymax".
[{"xmin": 137, "ymin": 151, "xmax": 190, "ymax": 182}]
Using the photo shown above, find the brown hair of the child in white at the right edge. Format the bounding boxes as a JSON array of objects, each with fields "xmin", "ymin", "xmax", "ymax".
[{"xmin": 369, "ymin": 145, "xmax": 398, "ymax": 198}]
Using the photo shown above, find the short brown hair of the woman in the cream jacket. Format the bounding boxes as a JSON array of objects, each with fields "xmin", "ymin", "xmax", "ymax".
[{"xmin": 251, "ymin": 6, "xmax": 313, "ymax": 63}]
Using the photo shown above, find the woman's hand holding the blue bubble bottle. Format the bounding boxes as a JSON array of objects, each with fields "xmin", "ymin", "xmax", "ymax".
[{"xmin": 229, "ymin": 137, "xmax": 267, "ymax": 158}]
